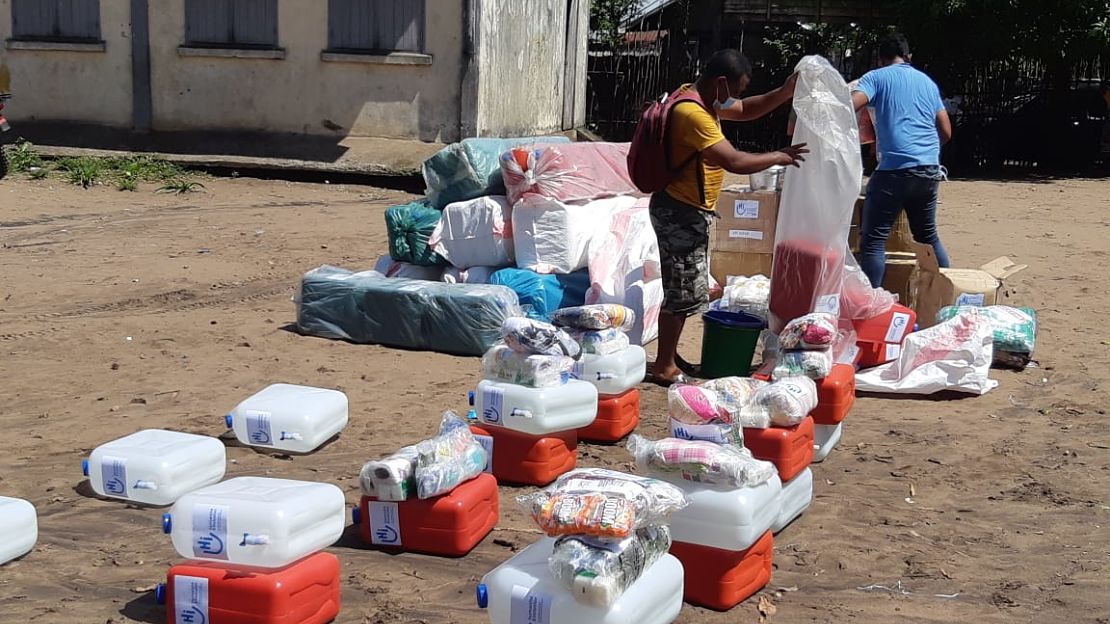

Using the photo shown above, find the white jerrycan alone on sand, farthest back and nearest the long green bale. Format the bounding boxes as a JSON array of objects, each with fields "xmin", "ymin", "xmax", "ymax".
[{"xmin": 225, "ymin": 383, "xmax": 347, "ymax": 453}]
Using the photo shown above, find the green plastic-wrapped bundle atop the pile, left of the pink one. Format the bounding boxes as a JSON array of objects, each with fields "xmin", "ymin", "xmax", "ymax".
[{"xmin": 424, "ymin": 137, "xmax": 571, "ymax": 209}]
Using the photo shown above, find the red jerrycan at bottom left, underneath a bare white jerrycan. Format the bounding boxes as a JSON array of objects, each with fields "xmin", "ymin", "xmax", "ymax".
[{"xmin": 157, "ymin": 553, "xmax": 340, "ymax": 624}]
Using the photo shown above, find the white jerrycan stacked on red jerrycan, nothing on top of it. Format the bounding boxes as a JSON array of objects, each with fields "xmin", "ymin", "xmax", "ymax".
[{"xmin": 162, "ymin": 476, "xmax": 346, "ymax": 567}]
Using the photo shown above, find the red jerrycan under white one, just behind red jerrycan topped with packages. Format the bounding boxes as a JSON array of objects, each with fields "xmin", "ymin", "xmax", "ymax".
[{"xmin": 471, "ymin": 425, "xmax": 578, "ymax": 485}]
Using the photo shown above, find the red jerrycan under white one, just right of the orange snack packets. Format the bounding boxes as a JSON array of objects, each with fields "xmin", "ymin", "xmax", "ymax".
[{"xmin": 670, "ymin": 531, "xmax": 775, "ymax": 611}]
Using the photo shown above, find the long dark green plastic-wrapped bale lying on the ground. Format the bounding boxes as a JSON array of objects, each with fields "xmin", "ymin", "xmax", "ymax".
[{"xmin": 295, "ymin": 265, "xmax": 523, "ymax": 356}]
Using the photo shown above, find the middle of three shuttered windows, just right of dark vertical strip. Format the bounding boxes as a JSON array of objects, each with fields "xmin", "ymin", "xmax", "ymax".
[{"xmin": 185, "ymin": 0, "xmax": 278, "ymax": 48}]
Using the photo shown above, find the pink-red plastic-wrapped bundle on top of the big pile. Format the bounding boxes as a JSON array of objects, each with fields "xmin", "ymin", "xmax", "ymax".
[{"xmin": 501, "ymin": 142, "xmax": 643, "ymax": 203}]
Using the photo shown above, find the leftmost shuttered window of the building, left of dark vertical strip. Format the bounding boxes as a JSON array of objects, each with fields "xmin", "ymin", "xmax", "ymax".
[{"xmin": 11, "ymin": 0, "xmax": 100, "ymax": 42}]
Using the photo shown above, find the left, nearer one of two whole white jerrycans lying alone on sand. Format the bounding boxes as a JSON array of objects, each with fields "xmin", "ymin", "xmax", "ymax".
[{"xmin": 81, "ymin": 429, "xmax": 228, "ymax": 505}]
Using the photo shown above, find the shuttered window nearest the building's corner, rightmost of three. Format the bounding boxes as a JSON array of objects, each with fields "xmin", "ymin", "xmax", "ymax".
[{"xmin": 327, "ymin": 0, "xmax": 424, "ymax": 52}]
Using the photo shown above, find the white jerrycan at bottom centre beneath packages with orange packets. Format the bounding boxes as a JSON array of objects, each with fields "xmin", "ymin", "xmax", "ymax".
[{"xmin": 477, "ymin": 537, "xmax": 684, "ymax": 624}]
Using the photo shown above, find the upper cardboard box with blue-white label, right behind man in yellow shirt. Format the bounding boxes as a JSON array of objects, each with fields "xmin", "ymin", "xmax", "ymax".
[{"xmin": 710, "ymin": 188, "xmax": 781, "ymax": 253}]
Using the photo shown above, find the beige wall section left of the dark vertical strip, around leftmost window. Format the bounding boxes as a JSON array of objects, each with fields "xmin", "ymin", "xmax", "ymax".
[{"xmin": 0, "ymin": 0, "xmax": 132, "ymax": 128}]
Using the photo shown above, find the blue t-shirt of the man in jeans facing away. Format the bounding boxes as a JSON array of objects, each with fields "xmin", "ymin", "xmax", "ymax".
[{"xmin": 856, "ymin": 63, "xmax": 945, "ymax": 171}]
